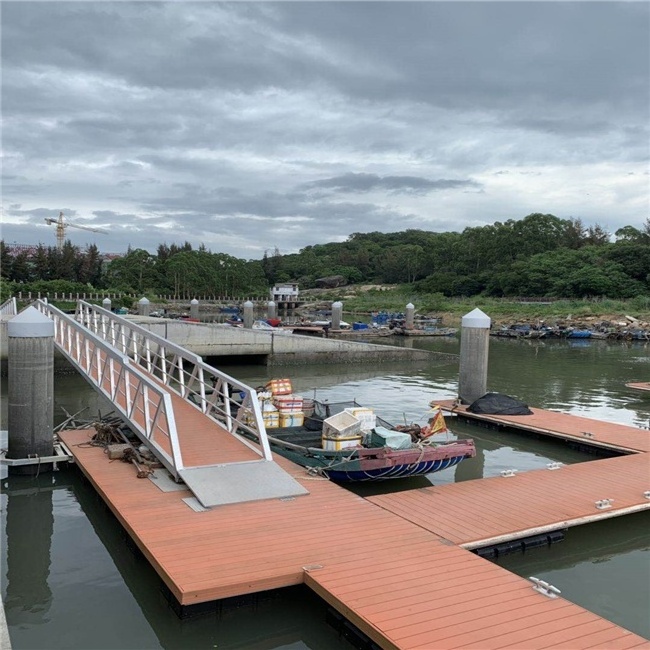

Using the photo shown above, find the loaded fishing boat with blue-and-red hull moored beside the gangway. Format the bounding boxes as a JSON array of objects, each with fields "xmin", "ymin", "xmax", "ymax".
[{"xmin": 246, "ymin": 395, "xmax": 476, "ymax": 482}]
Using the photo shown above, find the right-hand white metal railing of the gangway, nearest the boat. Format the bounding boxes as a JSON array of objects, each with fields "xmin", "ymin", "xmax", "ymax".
[{"xmin": 75, "ymin": 300, "xmax": 272, "ymax": 460}]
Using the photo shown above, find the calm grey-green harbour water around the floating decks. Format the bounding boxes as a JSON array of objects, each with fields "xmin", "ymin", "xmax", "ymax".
[{"xmin": 0, "ymin": 338, "xmax": 650, "ymax": 650}]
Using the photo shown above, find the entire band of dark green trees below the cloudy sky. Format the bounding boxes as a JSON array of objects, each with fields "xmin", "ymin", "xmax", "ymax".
[{"xmin": 0, "ymin": 214, "xmax": 650, "ymax": 299}]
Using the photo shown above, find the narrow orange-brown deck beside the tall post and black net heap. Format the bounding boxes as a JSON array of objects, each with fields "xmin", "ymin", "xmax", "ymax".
[{"xmin": 436, "ymin": 400, "xmax": 650, "ymax": 454}]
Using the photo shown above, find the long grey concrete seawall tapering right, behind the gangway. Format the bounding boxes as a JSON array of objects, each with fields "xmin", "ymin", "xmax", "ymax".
[{"xmin": 0, "ymin": 316, "xmax": 458, "ymax": 374}]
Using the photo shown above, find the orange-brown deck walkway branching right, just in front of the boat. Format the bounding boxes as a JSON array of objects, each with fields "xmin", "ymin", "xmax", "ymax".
[{"xmin": 368, "ymin": 454, "xmax": 650, "ymax": 549}]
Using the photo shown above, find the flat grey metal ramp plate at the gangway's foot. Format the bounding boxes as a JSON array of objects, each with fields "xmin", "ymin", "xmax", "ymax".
[{"xmin": 180, "ymin": 460, "xmax": 308, "ymax": 508}]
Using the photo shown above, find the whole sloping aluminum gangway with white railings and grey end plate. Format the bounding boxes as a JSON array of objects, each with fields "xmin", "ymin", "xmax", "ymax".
[{"xmin": 33, "ymin": 300, "xmax": 307, "ymax": 508}]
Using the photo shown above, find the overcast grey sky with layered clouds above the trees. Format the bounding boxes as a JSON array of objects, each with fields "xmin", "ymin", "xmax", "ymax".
[{"xmin": 0, "ymin": 0, "xmax": 650, "ymax": 259}]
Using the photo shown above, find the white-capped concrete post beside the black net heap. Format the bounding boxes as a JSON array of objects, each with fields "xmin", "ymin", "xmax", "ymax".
[{"xmin": 458, "ymin": 308, "xmax": 491, "ymax": 404}]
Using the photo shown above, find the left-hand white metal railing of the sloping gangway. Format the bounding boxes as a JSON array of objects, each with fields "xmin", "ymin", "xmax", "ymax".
[{"xmin": 32, "ymin": 300, "xmax": 184, "ymax": 480}]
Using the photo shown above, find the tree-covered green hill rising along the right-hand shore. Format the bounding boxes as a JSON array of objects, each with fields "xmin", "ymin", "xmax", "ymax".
[{"xmin": 263, "ymin": 214, "xmax": 650, "ymax": 299}]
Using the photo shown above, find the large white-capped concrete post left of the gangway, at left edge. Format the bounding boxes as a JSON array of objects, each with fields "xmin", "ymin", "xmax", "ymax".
[{"xmin": 7, "ymin": 307, "xmax": 54, "ymax": 476}]
